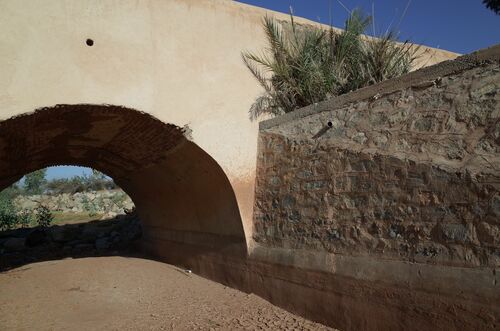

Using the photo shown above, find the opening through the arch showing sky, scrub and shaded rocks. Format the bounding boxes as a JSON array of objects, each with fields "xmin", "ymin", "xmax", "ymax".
[{"xmin": 0, "ymin": 166, "xmax": 142, "ymax": 271}]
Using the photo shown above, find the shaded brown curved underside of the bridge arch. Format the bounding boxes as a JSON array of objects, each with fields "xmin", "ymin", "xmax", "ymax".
[{"xmin": 0, "ymin": 104, "xmax": 246, "ymax": 263}]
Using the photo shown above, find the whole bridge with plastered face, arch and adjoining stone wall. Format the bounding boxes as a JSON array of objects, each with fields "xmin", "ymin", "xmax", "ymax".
[{"xmin": 0, "ymin": 0, "xmax": 500, "ymax": 330}]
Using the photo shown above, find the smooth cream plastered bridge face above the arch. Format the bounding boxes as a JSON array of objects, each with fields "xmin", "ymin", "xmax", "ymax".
[{"xmin": 0, "ymin": 0, "xmax": 456, "ymax": 244}]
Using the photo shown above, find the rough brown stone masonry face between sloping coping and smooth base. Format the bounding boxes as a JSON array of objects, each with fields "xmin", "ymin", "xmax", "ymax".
[{"xmin": 254, "ymin": 61, "xmax": 500, "ymax": 267}]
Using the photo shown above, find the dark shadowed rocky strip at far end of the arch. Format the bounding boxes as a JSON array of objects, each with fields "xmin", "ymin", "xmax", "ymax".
[{"xmin": 0, "ymin": 212, "xmax": 142, "ymax": 272}]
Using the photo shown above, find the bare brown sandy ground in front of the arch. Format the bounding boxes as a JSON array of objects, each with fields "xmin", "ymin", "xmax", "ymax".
[{"xmin": 0, "ymin": 256, "xmax": 332, "ymax": 331}]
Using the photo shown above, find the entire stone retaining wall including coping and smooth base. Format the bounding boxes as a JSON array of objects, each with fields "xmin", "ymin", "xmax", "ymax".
[{"xmin": 244, "ymin": 46, "xmax": 500, "ymax": 330}]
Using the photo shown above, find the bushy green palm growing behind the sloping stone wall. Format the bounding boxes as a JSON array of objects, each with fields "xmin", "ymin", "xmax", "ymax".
[{"xmin": 242, "ymin": 10, "xmax": 416, "ymax": 120}]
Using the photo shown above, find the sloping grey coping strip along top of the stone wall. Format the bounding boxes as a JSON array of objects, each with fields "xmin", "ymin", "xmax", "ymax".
[{"xmin": 259, "ymin": 44, "xmax": 500, "ymax": 131}]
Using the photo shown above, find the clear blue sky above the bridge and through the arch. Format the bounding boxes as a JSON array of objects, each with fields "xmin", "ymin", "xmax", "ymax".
[{"xmin": 47, "ymin": 0, "xmax": 500, "ymax": 179}]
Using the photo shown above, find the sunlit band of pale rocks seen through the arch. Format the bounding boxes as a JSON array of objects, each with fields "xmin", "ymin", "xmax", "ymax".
[{"xmin": 14, "ymin": 189, "xmax": 134, "ymax": 217}]
